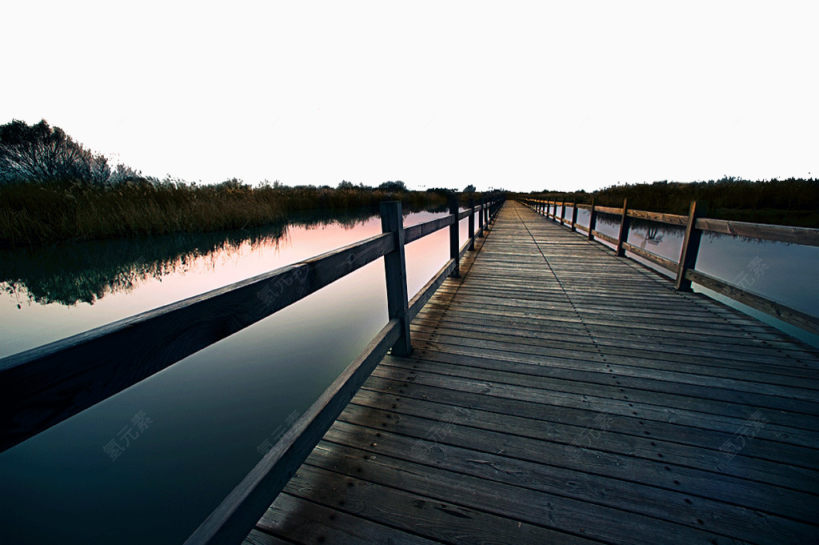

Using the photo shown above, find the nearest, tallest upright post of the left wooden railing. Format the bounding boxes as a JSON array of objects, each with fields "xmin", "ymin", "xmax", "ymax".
[{"xmin": 381, "ymin": 201, "xmax": 412, "ymax": 356}]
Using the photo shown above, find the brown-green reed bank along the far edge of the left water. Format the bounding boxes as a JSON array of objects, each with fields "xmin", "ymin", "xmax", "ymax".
[{"xmin": 0, "ymin": 181, "xmax": 443, "ymax": 247}]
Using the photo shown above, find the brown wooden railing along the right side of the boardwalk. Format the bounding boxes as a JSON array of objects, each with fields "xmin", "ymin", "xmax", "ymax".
[{"xmin": 521, "ymin": 199, "xmax": 819, "ymax": 334}]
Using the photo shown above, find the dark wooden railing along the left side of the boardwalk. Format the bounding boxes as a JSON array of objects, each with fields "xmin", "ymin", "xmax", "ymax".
[{"xmin": 0, "ymin": 198, "xmax": 502, "ymax": 545}]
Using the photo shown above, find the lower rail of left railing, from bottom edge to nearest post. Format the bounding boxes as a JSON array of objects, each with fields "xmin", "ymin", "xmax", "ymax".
[{"xmin": 185, "ymin": 320, "xmax": 400, "ymax": 545}]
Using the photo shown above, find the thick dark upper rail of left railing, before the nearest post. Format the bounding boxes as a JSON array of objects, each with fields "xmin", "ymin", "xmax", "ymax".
[{"xmin": 0, "ymin": 230, "xmax": 394, "ymax": 450}]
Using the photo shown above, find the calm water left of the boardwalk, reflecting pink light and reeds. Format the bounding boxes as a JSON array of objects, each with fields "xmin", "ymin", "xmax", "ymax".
[{"xmin": 0, "ymin": 207, "xmax": 477, "ymax": 544}]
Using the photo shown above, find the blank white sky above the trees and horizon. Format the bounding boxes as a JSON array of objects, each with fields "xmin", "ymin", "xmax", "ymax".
[{"xmin": 0, "ymin": 0, "xmax": 819, "ymax": 191}]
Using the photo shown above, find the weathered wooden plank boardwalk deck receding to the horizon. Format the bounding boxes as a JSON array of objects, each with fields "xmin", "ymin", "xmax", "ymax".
[{"xmin": 245, "ymin": 202, "xmax": 819, "ymax": 545}]
